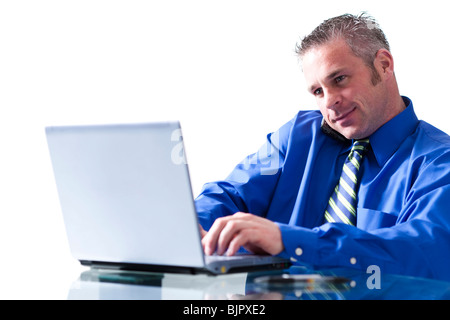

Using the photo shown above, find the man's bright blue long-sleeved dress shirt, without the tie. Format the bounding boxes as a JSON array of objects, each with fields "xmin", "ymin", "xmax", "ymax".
[{"xmin": 196, "ymin": 97, "xmax": 450, "ymax": 280}]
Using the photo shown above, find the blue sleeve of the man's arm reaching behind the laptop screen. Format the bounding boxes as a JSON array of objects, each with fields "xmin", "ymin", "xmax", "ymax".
[{"xmin": 195, "ymin": 121, "xmax": 293, "ymax": 230}]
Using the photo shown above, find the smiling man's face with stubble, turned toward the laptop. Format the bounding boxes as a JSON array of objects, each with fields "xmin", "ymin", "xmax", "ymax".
[{"xmin": 303, "ymin": 40, "xmax": 390, "ymax": 139}]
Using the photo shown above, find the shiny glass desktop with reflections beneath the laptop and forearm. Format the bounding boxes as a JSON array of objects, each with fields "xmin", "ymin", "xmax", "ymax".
[{"xmin": 68, "ymin": 267, "xmax": 450, "ymax": 300}]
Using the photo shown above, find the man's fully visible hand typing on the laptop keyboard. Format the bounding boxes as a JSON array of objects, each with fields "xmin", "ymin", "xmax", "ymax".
[{"xmin": 200, "ymin": 212, "xmax": 284, "ymax": 256}]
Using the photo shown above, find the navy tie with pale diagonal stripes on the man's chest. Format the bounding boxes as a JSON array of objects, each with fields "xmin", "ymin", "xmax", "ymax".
[{"xmin": 325, "ymin": 139, "xmax": 369, "ymax": 226}]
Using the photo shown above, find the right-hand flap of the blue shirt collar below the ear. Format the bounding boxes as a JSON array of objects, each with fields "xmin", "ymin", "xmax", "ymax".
[{"xmin": 369, "ymin": 97, "xmax": 419, "ymax": 167}]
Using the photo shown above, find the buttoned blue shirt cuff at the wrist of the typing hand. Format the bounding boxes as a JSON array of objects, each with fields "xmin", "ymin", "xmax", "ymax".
[{"xmin": 277, "ymin": 223, "xmax": 318, "ymax": 265}]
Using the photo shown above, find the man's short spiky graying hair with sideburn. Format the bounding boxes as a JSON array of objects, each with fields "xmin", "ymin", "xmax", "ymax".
[{"xmin": 295, "ymin": 12, "xmax": 390, "ymax": 84}]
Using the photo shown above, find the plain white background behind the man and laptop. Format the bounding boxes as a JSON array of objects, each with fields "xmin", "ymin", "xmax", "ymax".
[{"xmin": 0, "ymin": 0, "xmax": 450, "ymax": 299}]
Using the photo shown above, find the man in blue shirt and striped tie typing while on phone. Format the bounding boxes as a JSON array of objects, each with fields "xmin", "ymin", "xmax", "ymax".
[{"xmin": 196, "ymin": 15, "xmax": 450, "ymax": 280}]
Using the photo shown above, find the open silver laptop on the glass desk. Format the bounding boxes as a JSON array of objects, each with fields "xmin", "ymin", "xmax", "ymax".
[{"xmin": 46, "ymin": 121, "xmax": 289, "ymax": 274}]
